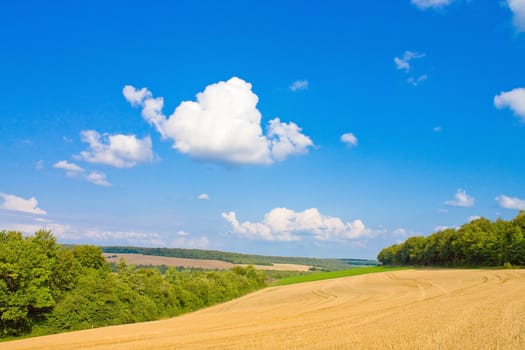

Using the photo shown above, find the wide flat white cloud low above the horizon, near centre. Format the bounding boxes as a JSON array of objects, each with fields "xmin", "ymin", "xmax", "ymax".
[{"xmin": 222, "ymin": 208, "xmax": 371, "ymax": 241}]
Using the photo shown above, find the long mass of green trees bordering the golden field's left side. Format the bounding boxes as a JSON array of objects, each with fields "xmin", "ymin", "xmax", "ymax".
[{"xmin": 0, "ymin": 230, "xmax": 265, "ymax": 337}]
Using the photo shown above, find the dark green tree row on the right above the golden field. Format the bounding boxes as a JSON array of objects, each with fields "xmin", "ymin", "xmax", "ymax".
[{"xmin": 377, "ymin": 211, "xmax": 525, "ymax": 267}]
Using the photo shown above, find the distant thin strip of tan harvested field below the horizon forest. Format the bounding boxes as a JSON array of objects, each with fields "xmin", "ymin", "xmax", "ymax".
[{"xmin": 104, "ymin": 253, "xmax": 310, "ymax": 271}]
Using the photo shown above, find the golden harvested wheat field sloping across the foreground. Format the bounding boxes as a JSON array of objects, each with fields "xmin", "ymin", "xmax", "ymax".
[{"xmin": 1, "ymin": 270, "xmax": 525, "ymax": 350}]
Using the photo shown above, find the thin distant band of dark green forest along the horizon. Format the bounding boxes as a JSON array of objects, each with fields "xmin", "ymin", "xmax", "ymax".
[{"xmin": 102, "ymin": 247, "xmax": 377, "ymax": 271}]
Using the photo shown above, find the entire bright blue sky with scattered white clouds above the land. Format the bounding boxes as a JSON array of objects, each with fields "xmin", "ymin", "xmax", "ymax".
[{"xmin": 0, "ymin": 0, "xmax": 525, "ymax": 258}]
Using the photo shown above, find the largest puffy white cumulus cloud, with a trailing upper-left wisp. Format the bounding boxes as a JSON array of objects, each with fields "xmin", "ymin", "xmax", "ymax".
[{"xmin": 123, "ymin": 77, "xmax": 313, "ymax": 164}]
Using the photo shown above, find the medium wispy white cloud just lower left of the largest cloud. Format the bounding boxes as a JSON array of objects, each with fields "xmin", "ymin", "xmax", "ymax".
[{"xmin": 77, "ymin": 130, "xmax": 153, "ymax": 168}]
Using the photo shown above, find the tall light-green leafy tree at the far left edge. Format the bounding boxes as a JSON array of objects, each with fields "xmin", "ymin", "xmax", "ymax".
[{"xmin": 0, "ymin": 231, "xmax": 75, "ymax": 336}]
